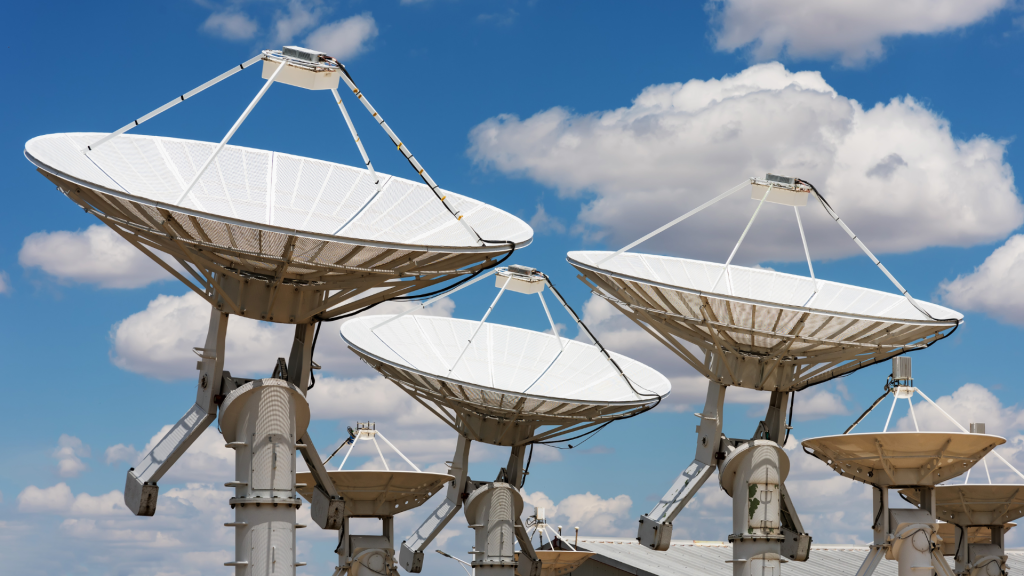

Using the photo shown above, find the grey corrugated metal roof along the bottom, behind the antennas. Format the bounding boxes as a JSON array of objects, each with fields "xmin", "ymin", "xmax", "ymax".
[{"xmin": 561, "ymin": 538, "xmax": 1024, "ymax": 576}]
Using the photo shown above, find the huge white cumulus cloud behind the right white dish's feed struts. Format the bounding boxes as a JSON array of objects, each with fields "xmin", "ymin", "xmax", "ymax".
[{"xmin": 469, "ymin": 63, "xmax": 1024, "ymax": 263}]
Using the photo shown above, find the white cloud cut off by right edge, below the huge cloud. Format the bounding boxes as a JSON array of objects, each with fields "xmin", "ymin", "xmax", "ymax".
[{"xmin": 939, "ymin": 234, "xmax": 1024, "ymax": 326}]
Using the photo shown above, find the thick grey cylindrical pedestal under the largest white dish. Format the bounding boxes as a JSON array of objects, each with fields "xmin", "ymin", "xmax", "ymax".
[{"xmin": 220, "ymin": 378, "xmax": 309, "ymax": 576}]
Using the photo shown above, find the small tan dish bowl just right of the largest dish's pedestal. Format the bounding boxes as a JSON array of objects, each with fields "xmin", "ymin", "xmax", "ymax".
[{"xmin": 295, "ymin": 470, "xmax": 454, "ymax": 517}]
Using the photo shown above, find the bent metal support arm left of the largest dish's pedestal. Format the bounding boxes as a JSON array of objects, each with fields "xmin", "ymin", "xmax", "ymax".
[{"xmin": 125, "ymin": 308, "xmax": 227, "ymax": 516}]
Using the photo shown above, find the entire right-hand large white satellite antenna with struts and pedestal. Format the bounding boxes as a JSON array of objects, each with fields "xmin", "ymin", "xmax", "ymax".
[{"xmin": 567, "ymin": 174, "xmax": 963, "ymax": 574}]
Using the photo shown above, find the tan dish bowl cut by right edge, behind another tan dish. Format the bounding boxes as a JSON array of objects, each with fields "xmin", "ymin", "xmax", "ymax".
[{"xmin": 900, "ymin": 484, "xmax": 1024, "ymax": 526}]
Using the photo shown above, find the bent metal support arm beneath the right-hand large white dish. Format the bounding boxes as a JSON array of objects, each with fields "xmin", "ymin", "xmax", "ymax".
[{"xmin": 637, "ymin": 381, "xmax": 725, "ymax": 550}]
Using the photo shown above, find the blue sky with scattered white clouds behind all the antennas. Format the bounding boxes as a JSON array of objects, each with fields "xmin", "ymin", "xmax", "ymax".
[{"xmin": 0, "ymin": 0, "xmax": 1024, "ymax": 575}]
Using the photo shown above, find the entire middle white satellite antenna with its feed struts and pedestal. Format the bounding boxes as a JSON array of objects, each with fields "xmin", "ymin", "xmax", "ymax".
[{"xmin": 341, "ymin": 266, "xmax": 671, "ymax": 576}]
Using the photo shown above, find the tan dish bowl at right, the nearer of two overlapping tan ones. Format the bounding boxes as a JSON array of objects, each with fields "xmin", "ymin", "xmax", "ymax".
[{"xmin": 803, "ymin": 433, "xmax": 1006, "ymax": 487}]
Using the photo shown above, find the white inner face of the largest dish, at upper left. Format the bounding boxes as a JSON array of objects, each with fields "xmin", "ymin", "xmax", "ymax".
[{"xmin": 26, "ymin": 133, "xmax": 532, "ymax": 248}]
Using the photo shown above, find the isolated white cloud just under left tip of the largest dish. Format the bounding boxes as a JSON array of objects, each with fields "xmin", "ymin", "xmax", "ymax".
[{"xmin": 17, "ymin": 224, "xmax": 172, "ymax": 288}]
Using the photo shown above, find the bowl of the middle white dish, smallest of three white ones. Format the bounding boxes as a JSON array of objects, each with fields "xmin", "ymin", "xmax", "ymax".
[{"xmin": 341, "ymin": 316, "xmax": 671, "ymax": 444}]
